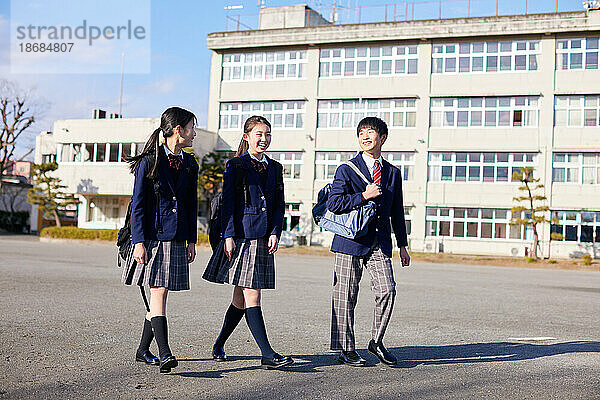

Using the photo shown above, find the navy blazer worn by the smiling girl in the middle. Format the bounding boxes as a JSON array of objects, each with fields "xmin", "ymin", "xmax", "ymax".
[{"xmin": 221, "ymin": 152, "xmax": 285, "ymax": 239}]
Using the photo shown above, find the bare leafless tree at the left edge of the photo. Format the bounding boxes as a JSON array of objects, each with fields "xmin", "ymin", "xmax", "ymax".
[{"xmin": 0, "ymin": 79, "xmax": 36, "ymax": 189}]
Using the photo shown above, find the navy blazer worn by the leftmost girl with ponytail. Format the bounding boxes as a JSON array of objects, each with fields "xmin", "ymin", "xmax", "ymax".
[{"xmin": 131, "ymin": 146, "xmax": 198, "ymax": 244}]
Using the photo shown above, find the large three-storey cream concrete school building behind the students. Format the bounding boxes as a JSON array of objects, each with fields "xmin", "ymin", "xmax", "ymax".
[{"xmin": 207, "ymin": 5, "xmax": 600, "ymax": 257}]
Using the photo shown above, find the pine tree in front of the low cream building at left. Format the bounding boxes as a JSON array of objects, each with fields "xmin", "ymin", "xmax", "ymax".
[{"xmin": 27, "ymin": 162, "xmax": 79, "ymax": 227}]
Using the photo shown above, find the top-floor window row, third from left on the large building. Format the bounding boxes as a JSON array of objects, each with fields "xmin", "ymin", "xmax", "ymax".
[{"xmin": 431, "ymin": 40, "xmax": 540, "ymax": 74}]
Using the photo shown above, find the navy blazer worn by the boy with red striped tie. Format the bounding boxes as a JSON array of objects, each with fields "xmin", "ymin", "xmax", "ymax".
[{"xmin": 327, "ymin": 152, "xmax": 408, "ymax": 257}]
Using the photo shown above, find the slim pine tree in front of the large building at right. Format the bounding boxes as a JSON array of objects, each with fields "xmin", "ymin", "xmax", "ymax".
[{"xmin": 510, "ymin": 167, "xmax": 552, "ymax": 259}]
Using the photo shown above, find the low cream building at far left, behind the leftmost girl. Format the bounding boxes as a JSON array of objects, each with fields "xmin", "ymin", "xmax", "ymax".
[{"xmin": 32, "ymin": 110, "xmax": 216, "ymax": 230}]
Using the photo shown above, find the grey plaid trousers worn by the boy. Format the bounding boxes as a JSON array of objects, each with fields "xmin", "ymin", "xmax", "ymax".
[{"xmin": 331, "ymin": 246, "xmax": 396, "ymax": 351}]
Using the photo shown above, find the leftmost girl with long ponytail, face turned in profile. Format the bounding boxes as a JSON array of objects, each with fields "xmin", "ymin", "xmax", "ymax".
[{"xmin": 122, "ymin": 107, "xmax": 198, "ymax": 372}]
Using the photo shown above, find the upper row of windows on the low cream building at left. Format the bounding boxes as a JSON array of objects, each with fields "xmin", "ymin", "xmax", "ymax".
[{"xmin": 57, "ymin": 143, "xmax": 144, "ymax": 163}]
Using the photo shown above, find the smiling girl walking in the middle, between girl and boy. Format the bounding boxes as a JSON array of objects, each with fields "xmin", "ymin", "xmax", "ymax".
[{"xmin": 204, "ymin": 116, "xmax": 293, "ymax": 369}]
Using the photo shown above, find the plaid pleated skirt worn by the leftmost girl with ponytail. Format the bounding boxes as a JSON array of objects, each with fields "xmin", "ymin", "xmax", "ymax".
[{"xmin": 121, "ymin": 240, "xmax": 190, "ymax": 291}]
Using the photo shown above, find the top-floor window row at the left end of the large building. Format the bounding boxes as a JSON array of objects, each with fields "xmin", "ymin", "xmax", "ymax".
[{"xmin": 223, "ymin": 50, "xmax": 306, "ymax": 81}]
